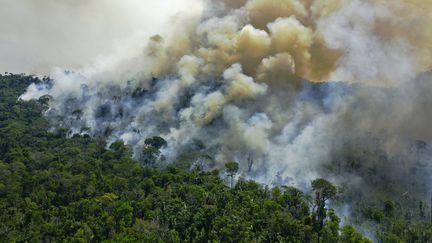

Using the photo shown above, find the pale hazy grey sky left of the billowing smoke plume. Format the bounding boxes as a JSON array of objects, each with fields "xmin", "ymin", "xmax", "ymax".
[{"xmin": 0, "ymin": 0, "xmax": 202, "ymax": 75}]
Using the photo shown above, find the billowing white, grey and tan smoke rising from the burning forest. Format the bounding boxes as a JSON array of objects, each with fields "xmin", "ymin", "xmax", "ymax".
[{"xmin": 16, "ymin": 0, "xmax": 432, "ymax": 199}]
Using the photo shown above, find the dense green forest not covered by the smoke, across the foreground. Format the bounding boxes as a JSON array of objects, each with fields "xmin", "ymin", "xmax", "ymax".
[{"xmin": 0, "ymin": 74, "xmax": 432, "ymax": 242}]
